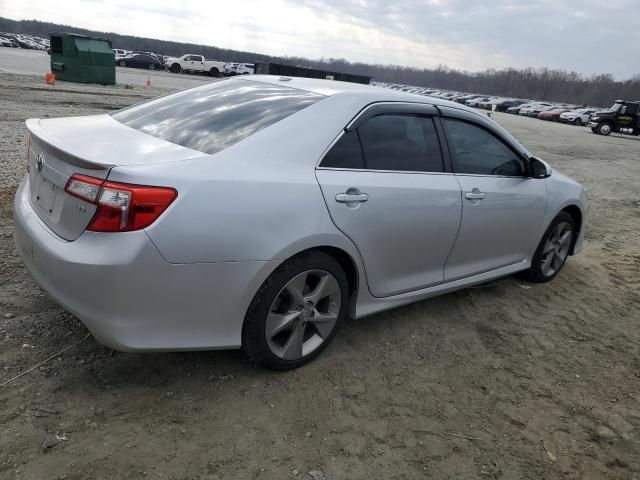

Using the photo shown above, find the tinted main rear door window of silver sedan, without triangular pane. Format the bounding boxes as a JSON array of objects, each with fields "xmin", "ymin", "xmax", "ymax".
[{"xmin": 358, "ymin": 115, "xmax": 443, "ymax": 172}]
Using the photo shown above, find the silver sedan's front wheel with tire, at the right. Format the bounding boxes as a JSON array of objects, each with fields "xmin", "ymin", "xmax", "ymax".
[{"xmin": 526, "ymin": 212, "xmax": 575, "ymax": 283}]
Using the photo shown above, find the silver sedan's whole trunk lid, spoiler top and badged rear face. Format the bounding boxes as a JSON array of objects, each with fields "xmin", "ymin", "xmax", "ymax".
[{"xmin": 27, "ymin": 115, "xmax": 204, "ymax": 241}]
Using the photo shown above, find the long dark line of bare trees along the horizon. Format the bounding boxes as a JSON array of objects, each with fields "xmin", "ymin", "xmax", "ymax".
[{"xmin": 0, "ymin": 17, "xmax": 640, "ymax": 106}]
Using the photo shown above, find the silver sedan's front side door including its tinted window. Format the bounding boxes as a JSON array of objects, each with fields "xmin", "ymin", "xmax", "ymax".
[{"xmin": 441, "ymin": 107, "xmax": 547, "ymax": 281}]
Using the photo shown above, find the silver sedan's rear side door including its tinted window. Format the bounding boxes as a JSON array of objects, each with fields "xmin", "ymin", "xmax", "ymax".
[{"xmin": 316, "ymin": 104, "xmax": 462, "ymax": 297}]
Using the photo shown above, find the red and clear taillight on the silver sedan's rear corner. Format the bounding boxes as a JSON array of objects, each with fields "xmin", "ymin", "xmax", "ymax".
[{"xmin": 65, "ymin": 175, "xmax": 178, "ymax": 232}]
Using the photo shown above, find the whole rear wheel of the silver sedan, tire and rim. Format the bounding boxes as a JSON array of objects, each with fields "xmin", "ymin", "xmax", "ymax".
[{"xmin": 242, "ymin": 252, "xmax": 349, "ymax": 370}]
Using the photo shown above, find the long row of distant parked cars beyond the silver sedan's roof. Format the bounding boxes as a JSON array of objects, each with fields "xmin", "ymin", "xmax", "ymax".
[{"xmin": 379, "ymin": 84, "xmax": 602, "ymax": 126}]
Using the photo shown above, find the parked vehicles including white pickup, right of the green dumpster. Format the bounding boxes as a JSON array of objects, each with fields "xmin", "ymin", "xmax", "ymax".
[{"xmin": 113, "ymin": 48, "xmax": 255, "ymax": 77}]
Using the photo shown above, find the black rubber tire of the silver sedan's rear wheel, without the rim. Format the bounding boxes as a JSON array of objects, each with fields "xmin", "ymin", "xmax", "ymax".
[{"xmin": 242, "ymin": 251, "xmax": 349, "ymax": 370}]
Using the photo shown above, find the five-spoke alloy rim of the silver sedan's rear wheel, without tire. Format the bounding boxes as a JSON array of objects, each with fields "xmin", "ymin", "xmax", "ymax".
[{"xmin": 265, "ymin": 270, "xmax": 342, "ymax": 360}]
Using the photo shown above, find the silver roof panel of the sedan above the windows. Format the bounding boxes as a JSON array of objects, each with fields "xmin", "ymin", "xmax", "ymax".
[{"xmin": 238, "ymin": 75, "xmax": 478, "ymax": 114}]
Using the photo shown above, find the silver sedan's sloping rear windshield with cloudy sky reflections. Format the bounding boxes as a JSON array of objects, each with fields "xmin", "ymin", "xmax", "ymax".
[{"xmin": 112, "ymin": 79, "xmax": 325, "ymax": 154}]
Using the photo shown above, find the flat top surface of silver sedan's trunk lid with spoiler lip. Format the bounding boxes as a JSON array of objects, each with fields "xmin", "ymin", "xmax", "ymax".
[{"xmin": 27, "ymin": 114, "xmax": 206, "ymax": 168}]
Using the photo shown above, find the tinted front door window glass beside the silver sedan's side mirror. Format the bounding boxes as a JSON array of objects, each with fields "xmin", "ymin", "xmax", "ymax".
[{"xmin": 443, "ymin": 118, "xmax": 526, "ymax": 176}]
